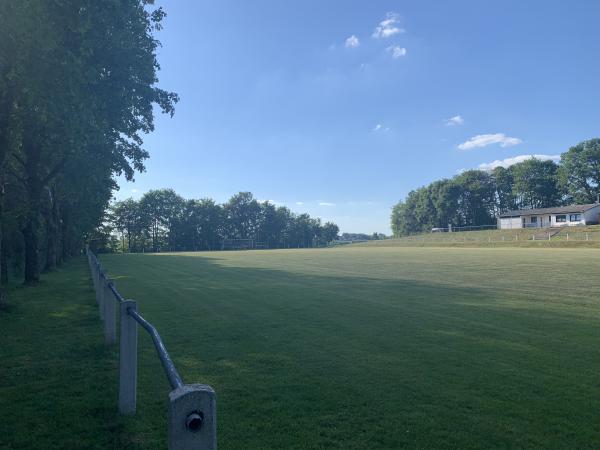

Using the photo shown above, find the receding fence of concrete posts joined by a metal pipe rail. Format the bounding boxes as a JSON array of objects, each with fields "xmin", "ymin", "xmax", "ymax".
[{"xmin": 87, "ymin": 249, "xmax": 217, "ymax": 450}]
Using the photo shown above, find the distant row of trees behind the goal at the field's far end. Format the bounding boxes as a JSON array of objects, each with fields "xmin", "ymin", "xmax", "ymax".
[{"xmin": 109, "ymin": 189, "xmax": 339, "ymax": 252}]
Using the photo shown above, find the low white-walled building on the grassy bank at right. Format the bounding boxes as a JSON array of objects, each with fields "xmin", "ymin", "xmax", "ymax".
[{"xmin": 498, "ymin": 203, "xmax": 600, "ymax": 230}]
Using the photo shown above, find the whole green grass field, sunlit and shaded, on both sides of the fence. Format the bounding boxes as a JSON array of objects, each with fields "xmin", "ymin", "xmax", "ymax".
[{"xmin": 0, "ymin": 246, "xmax": 600, "ymax": 449}]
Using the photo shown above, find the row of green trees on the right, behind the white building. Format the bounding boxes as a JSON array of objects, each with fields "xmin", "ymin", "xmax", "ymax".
[{"xmin": 391, "ymin": 139, "xmax": 600, "ymax": 236}]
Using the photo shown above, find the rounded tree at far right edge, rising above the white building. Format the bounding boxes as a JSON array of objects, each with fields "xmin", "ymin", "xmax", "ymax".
[{"xmin": 558, "ymin": 138, "xmax": 600, "ymax": 203}]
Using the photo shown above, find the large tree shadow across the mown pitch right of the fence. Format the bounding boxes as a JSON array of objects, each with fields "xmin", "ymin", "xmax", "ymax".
[{"xmin": 98, "ymin": 254, "xmax": 600, "ymax": 448}]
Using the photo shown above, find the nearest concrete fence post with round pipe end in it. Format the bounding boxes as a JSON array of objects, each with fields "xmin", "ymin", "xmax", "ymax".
[{"xmin": 168, "ymin": 384, "xmax": 217, "ymax": 450}]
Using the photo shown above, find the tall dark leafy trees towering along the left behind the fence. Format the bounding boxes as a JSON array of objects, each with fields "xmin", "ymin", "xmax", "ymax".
[{"xmin": 0, "ymin": 0, "xmax": 178, "ymax": 294}]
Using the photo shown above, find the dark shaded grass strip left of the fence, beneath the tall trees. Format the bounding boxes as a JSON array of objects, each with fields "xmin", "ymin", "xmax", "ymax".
[{"xmin": 0, "ymin": 259, "xmax": 142, "ymax": 449}]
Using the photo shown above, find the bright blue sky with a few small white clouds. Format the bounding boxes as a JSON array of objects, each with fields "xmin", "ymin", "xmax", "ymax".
[{"xmin": 116, "ymin": 0, "xmax": 600, "ymax": 233}]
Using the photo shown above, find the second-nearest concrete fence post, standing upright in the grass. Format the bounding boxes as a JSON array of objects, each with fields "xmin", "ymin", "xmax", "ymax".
[{"xmin": 119, "ymin": 300, "xmax": 138, "ymax": 416}]
